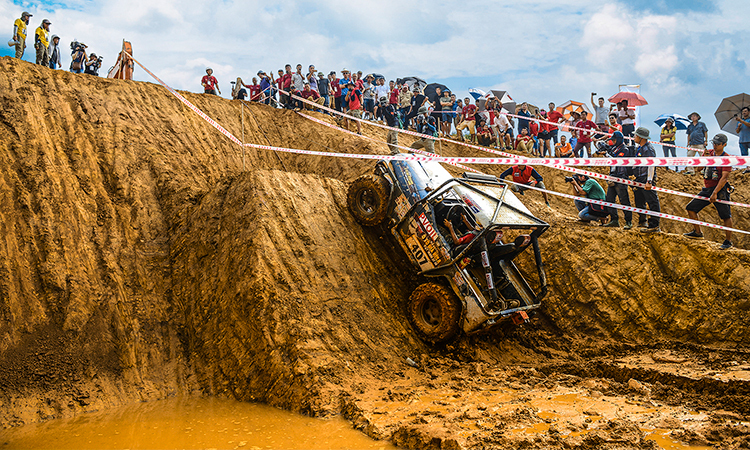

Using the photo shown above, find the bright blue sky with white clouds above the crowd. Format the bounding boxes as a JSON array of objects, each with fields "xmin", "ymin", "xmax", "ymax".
[{"xmin": 0, "ymin": 0, "xmax": 750, "ymax": 154}]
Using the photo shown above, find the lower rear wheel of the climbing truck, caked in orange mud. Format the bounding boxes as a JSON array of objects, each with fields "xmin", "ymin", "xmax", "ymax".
[{"xmin": 407, "ymin": 283, "xmax": 461, "ymax": 344}]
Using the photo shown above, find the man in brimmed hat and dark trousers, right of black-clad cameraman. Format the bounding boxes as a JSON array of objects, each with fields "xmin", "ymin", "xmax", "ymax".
[{"xmin": 633, "ymin": 127, "xmax": 661, "ymax": 233}]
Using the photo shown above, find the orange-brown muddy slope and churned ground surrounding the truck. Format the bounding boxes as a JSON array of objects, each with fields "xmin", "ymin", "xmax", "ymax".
[{"xmin": 0, "ymin": 57, "xmax": 750, "ymax": 449}]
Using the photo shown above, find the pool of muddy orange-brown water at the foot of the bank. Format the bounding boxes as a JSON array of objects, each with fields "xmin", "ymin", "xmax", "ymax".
[{"xmin": 0, "ymin": 397, "xmax": 397, "ymax": 450}]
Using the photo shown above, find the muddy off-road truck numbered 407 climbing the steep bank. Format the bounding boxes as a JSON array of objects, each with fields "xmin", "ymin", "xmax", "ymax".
[{"xmin": 347, "ymin": 160, "xmax": 549, "ymax": 344}]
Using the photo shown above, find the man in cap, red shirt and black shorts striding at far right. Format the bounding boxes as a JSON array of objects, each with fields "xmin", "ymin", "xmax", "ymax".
[{"xmin": 684, "ymin": 133, "xmax": 734, "ymax": 250}]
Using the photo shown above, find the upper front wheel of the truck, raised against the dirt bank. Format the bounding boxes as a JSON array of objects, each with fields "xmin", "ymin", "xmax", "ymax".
[{"xmin": 346, "ymin": 175, "xmax": 390, "ymax": 227}]
